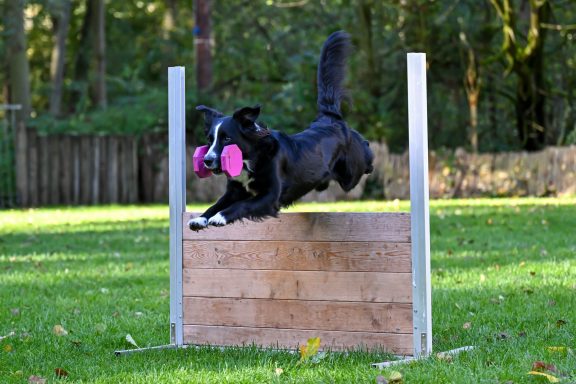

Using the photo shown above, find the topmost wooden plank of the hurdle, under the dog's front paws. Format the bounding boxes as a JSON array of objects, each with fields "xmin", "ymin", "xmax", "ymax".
[{"xmin": 183, "ymin": 212, "xmax": 410, "ymax": 243}]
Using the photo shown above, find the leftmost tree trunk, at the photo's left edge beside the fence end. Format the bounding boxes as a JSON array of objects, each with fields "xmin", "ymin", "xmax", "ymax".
[{"xmin": 4, "ymin": 0, "xmax": 31, "ymax": 206}]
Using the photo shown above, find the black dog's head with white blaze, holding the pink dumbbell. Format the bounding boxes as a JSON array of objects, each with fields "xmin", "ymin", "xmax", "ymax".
[{"xmin": 196, "ymin": 105, "xmax": 270, "ymax": 173}]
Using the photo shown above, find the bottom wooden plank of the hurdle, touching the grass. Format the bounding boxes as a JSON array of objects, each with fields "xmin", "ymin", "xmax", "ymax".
[{"xmin": 184, "ymin": 325, "xmax": 413, "ymax": 355}]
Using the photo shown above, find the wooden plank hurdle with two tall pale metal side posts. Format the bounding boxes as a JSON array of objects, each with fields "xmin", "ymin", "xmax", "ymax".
[{"xmin": 113, "ymin": 53, "xmax": 432, "ymax": 358}]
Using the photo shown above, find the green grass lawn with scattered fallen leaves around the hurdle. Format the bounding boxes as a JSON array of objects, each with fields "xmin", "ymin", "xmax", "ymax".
[{"xmin": 0, "ymin": 199, "xmax": 576, "ymax": 383}]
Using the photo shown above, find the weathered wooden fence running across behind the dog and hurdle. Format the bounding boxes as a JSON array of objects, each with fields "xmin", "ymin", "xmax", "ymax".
[{"xmin": 0, "ymin": 134, "xmax": 576, "ymax": 207}]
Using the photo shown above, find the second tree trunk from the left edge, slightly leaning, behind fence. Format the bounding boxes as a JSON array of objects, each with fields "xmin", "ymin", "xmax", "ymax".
[{"xmin": 50, "ymin": 0, "xmax": 71, "ymax": 117}]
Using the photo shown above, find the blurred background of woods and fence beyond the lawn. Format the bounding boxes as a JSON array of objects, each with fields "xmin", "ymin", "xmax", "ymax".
[{"xmin": 0, "ymin": 0, "xmax": 576, "ymax": 207}]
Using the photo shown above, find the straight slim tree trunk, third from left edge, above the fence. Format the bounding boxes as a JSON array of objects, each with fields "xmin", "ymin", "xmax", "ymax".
[{"xmin": 91, "ymin": 0, "xmax": 108, "ymax": 108}]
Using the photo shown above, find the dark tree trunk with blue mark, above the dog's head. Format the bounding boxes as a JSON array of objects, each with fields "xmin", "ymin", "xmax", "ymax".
[{"xmin": 194, "ymin": 0, "xmax": 212, "ymax": 91}]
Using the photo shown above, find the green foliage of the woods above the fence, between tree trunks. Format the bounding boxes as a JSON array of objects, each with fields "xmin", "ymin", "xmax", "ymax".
[{"xmin": 6, "ymin": 0, "xmax": 576, "ymax": 151}]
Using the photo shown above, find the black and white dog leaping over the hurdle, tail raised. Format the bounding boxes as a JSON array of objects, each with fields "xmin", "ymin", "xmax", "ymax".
[{"xmin": 188, "ymin": 31, "xmax": 373, "ymax": 231}]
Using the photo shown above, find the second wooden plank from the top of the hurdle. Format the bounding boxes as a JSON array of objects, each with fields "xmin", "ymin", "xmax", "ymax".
[{"xmin": 183, "ymin": 240, "xmax": 412, "ymax": 272}]
